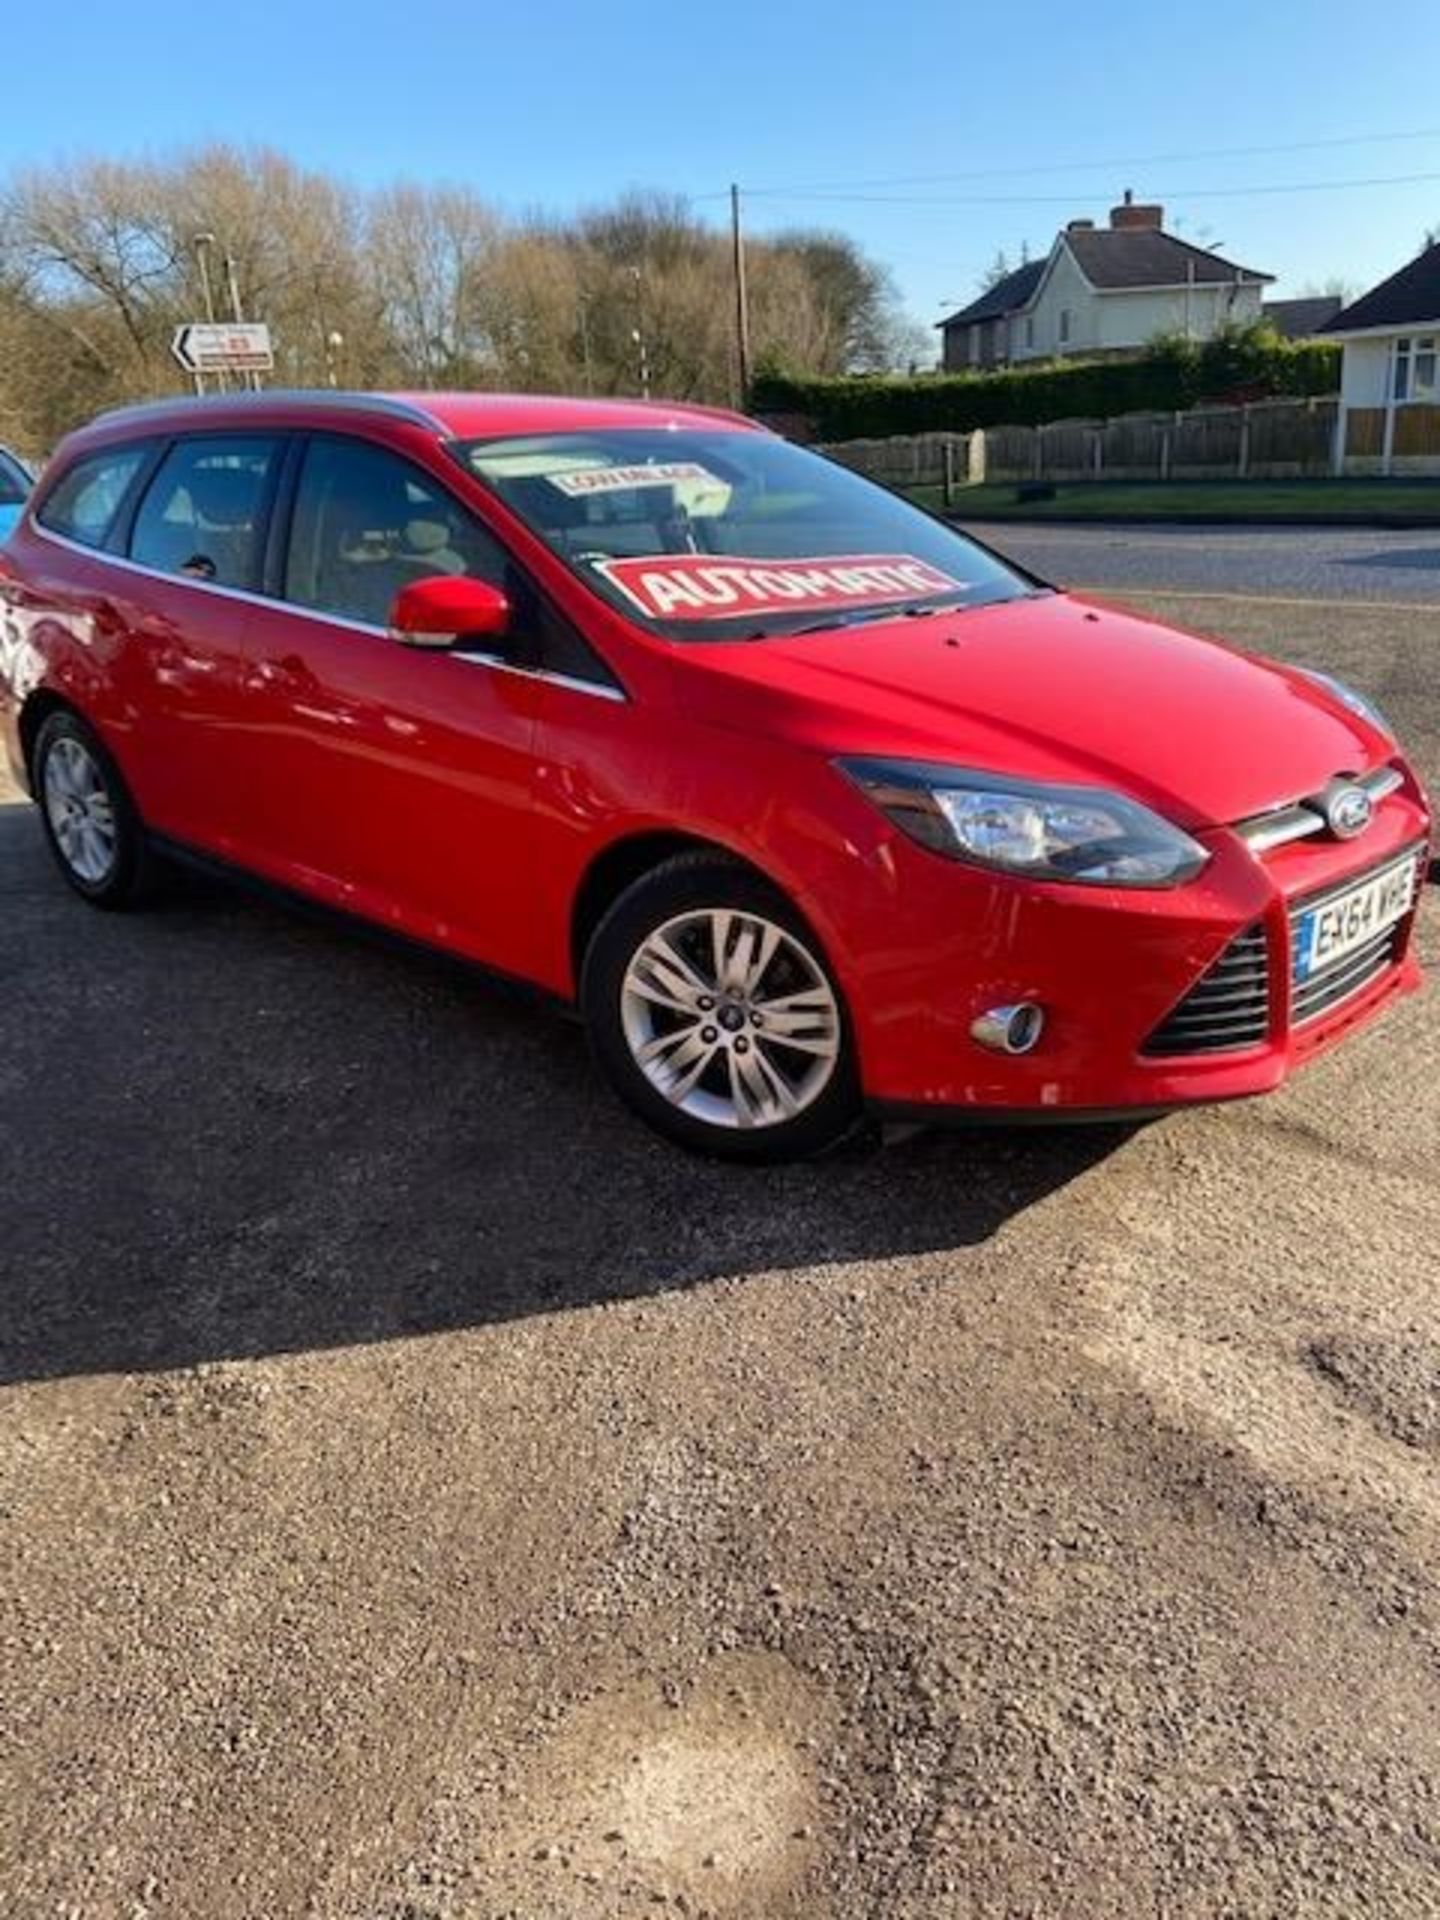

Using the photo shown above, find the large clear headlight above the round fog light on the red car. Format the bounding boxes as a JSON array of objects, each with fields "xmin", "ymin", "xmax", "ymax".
[{"xmin": 837, "ymin": 760, "xmax": 1210, "ymax": 887}]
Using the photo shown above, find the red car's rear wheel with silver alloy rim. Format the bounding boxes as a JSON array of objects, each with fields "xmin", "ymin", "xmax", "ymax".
[{"xmin": 31, "ymin": 710, "xmax": 150, "ymax": 906}]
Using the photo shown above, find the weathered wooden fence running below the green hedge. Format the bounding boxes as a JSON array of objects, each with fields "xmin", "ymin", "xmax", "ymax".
[{"xmin": 818, "ymin": 396, "xmax": 1338, "ymax": 495}]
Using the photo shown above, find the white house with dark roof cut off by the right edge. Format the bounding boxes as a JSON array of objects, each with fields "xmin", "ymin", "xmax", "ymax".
[{"xmin": 1325, "ymin": 242, "xmax": 1440, "ymax": 474}]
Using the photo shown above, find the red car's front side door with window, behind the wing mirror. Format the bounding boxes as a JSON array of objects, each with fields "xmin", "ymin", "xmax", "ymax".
[{"xmin": 246, "ymin": 432, "xmax": 541, "ymax": 973}]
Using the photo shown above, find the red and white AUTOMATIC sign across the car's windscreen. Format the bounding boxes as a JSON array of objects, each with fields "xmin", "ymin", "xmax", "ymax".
[{"xmin": 595, "ymin": 553, "xmax": 966, "ymax": 620}]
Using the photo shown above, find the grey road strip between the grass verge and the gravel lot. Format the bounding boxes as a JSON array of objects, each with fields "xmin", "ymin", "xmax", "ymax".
[{"xmin": 973, "ymin": 520, "xmax": 1440, "ymax": 602}]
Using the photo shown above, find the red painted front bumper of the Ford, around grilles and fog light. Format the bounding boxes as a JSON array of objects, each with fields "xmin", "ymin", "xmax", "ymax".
[{"xmin": 856, "ymin": 778, "xmax": 1428, "ymax": 1121}]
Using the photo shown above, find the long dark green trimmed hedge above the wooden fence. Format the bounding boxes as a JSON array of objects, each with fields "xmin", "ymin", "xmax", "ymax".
[{"xmin": 751, "ymin": 326, "xmax": 1340, "ymax": 440}]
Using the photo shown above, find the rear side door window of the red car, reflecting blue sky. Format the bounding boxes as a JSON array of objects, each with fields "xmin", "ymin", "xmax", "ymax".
[{"xmin": 131, "ymin": 434, "xmax": 280, "ymax": 589}]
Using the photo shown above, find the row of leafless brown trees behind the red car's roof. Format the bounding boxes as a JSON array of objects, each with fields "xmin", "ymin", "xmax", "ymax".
[{"xmin": 0, "ymin": 144, "xmax": 916, "ymax": 451}]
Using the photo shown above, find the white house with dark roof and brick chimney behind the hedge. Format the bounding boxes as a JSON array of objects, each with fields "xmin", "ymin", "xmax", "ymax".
[{"xmin": 939, "ymin": 194, "xmax": 1273, "ymax": 372}]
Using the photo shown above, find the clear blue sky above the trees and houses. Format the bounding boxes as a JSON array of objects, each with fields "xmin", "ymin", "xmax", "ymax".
[{"xmin": 0, "ymin": 0, "xmax": 1440, "ymax": 341}]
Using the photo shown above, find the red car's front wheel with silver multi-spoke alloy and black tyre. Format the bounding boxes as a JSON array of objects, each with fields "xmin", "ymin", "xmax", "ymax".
[{"xmin": 582, "ymin": 852, "xmax": 860, "ymax": 1160}]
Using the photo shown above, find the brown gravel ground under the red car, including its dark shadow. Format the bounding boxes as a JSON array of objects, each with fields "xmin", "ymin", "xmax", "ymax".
[{"xmin": 0, "ymin": 587, "xmax": 1440, "ymax": 1920}]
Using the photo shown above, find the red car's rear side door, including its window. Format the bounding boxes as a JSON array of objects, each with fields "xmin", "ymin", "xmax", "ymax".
[{"xmin": 121, "ymin": 432, "xmax": 284, "ymax": 858}]
